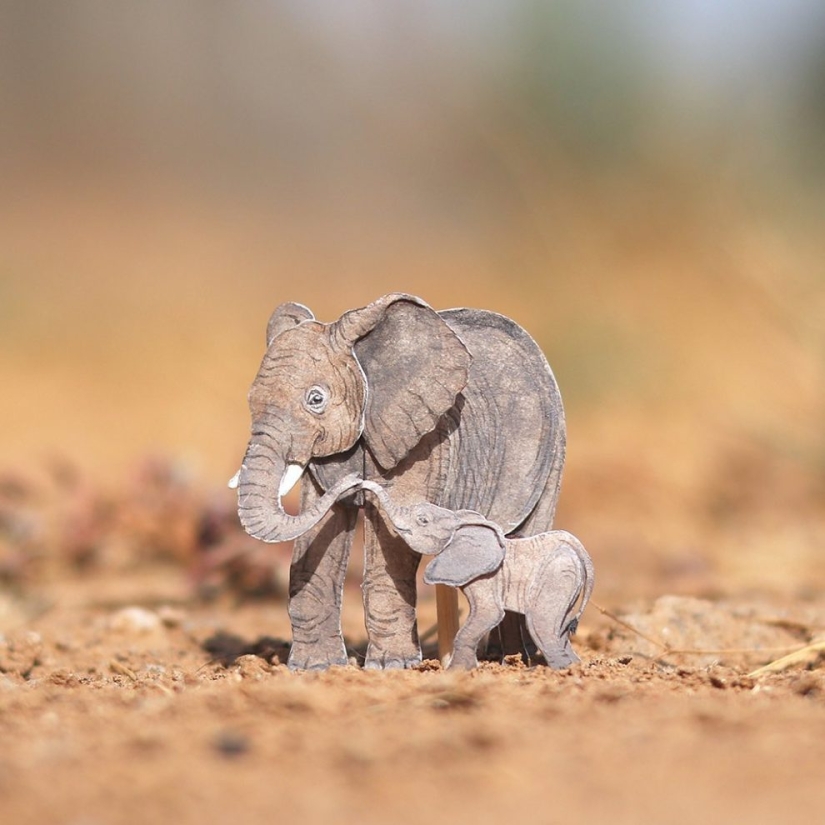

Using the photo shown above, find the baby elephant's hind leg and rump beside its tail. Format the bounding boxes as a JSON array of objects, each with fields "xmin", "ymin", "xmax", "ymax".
[{"xmin": 525, "ymin": 545, "xmax": 584, "ymax": 669}]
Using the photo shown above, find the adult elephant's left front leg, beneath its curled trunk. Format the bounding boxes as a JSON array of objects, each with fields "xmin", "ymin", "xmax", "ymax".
[{"xmin": 289, "ymin": 474, "xmax": 358, "ymax": 670}]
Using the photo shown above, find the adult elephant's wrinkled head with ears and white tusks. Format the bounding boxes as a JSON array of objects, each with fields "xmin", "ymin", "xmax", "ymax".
[{"xmin": 230, "ymin": 293, "xmax": 470, "ymax": 541}]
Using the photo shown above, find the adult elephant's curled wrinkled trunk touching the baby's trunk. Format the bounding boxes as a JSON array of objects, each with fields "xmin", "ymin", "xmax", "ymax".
[{"xmin": 233, "ymin": 441, "xmax": 361, "ymax": 543}]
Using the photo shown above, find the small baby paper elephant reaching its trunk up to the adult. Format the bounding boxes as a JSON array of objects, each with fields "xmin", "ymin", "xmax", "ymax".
[{"xmin": 362, "ymin": 481, "xmax": 594, "ymax": 668}]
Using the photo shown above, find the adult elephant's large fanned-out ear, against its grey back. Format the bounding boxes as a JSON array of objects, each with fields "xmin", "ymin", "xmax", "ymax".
[{"xmin": 333, "ymin": 293, "xmax": 471, "ymax": 470}]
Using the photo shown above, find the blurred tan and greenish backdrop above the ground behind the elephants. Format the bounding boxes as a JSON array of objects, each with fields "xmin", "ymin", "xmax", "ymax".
[{"xmin": 0, "ymin": 0, "xmax": 825, "ymax": 600}]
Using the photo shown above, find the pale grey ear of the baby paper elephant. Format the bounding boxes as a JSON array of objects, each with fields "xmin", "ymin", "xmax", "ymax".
[{"xmin": 424, "ymin": 523, "xmax": 504, "ymax": 587}]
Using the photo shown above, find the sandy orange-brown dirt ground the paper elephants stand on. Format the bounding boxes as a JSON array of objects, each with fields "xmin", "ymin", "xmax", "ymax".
[{"xmin": 0, "ymin": 462, "xmax": 825, "ymax": 825}]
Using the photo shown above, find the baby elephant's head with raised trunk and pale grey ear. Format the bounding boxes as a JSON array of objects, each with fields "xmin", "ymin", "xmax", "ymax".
[{"xmin": 361, "ymin": 481, "xmax": 506, "ymax": 587}]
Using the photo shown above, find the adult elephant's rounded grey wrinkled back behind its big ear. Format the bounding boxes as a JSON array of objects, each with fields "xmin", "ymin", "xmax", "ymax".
[{"xmin": 439, "ymin": 309, "xmax": 565, "ymax": 533}]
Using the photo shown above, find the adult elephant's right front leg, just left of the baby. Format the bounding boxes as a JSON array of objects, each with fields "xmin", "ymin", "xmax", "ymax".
[{"xmin": 362, "ymin": 503, "xmax": 421, "ymax": 670}]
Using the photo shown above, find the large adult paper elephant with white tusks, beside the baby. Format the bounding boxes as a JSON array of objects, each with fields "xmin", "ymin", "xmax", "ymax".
[{"xmin": 233, "ymin": 293, "xmax": 565, "ymax": 669}]
